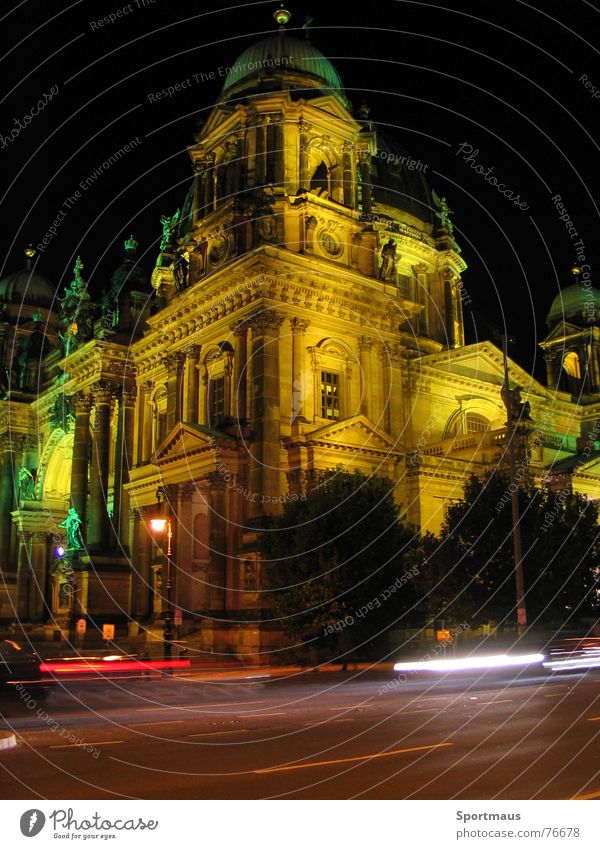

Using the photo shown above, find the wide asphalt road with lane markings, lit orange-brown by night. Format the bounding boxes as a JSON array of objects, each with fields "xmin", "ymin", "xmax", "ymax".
[{"xmin": 0, "ymin": 672, "xmax": 600, "ymax": 799}]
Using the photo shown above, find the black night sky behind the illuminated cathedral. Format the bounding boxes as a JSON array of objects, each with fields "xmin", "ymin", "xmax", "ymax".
[{"xmin": 0, "ymin": 0, "xmax": 600, "ymax": 376}]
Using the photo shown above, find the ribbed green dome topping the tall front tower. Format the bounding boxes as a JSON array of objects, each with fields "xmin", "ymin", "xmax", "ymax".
[{"xmin": 222, "ymin": 30, "xmax": 349, "ymax": 107}]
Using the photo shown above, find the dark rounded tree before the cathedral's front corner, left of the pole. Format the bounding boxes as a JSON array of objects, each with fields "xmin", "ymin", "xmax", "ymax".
[{"xmin": 259, "ymin": 469, "xmax": 416, "ymax": 654}]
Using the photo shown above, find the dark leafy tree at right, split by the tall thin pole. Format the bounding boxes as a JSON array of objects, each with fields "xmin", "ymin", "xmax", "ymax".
[{"xmin": 419, "ymin": 471, "xmax": 600, "ymax": 626}]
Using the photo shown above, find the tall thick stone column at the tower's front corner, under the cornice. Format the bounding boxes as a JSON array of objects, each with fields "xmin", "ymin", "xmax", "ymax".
[{"xmin": 250, "ymin": 310, "xmax": 283, "ymax": 516}]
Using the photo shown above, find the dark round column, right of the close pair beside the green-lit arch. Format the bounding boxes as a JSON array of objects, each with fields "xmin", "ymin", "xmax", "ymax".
[{"xmin": 87, "ymin": 381, "xmax": 114, "ymax": 551}]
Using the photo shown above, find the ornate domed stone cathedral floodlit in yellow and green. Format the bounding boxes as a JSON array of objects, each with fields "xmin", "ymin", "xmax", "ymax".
[{"xmin": 0, "ymin": 10, "xmax": 600, "ymax": 657}]
